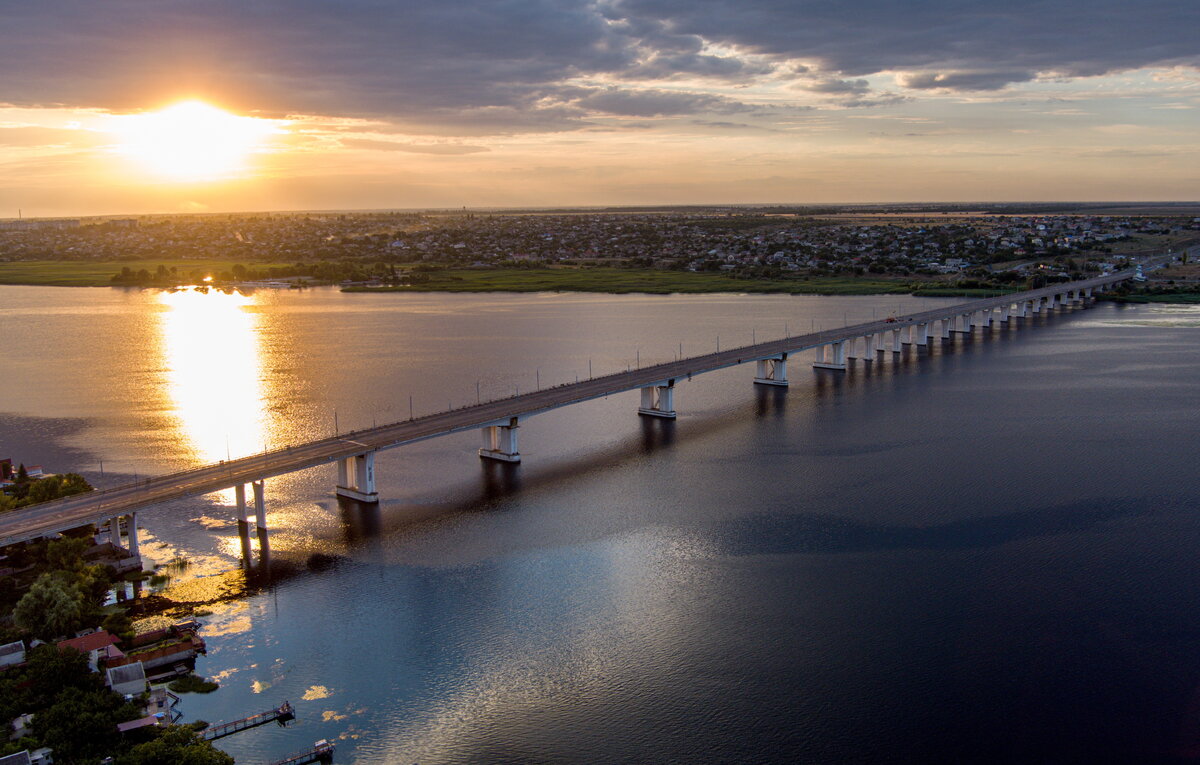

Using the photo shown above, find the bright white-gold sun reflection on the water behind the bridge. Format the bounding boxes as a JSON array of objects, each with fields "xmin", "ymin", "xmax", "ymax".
[{"xmin": 160, "ymin": 289, "xmax": 266, "ymax": 502}]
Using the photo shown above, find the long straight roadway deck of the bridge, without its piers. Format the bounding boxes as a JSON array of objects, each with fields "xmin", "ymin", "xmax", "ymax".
[{"xmin": 0, "ymin": 271, "xmax": 1134, "ymax": 547}]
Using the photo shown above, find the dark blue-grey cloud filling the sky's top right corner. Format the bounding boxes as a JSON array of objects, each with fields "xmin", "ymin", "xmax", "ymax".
[{"xmin": 610, "ymin": 0, "xmax": 1200, "ymax": 90}]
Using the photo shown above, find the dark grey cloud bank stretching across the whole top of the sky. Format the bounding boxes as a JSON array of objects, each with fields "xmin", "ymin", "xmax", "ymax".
[{"xmin": 0, "ymin": 0, "xmax": 1200, "ymax": 134}]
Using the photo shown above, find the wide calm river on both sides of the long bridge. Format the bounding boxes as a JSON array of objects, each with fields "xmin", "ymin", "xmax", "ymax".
[{"xmin": 0, "ymin": 287, "xmax": 1200, "ymax": 765}]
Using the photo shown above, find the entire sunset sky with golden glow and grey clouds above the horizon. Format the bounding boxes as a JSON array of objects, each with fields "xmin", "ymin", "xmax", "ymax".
[{"xmin": 0, "ymin": 0, "xmax": 1200, "ymax": 218}]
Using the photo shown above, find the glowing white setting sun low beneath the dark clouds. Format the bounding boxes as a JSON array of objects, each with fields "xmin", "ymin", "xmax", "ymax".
[{"xmin": 114, "ymin": 101, "xmax": 283, "ymax": 181}]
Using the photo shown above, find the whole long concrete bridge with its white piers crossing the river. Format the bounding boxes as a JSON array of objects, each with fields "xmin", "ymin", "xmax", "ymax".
[{"xmin": 0, "ymin": 269, "xmax": 1140, "ymax": 555}]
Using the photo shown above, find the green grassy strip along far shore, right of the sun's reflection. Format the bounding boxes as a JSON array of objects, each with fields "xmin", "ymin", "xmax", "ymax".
[{"xmin": 344, "ymin": 269, "xmax": 910, "ymax": 295}]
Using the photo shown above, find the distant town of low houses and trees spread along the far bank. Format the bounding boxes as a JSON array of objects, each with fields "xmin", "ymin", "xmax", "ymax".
[{"xmin": 0, "ymin": 206, "xmax": 1200, "ymax": 293}]
